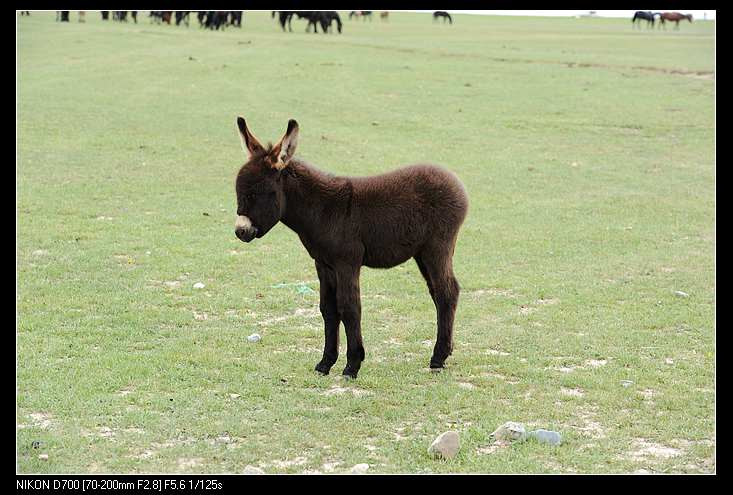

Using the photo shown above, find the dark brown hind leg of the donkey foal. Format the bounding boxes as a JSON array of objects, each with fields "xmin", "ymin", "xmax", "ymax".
[{"xmin": 415, "ymin": 240, "xmax": 460, "ymax": 368}]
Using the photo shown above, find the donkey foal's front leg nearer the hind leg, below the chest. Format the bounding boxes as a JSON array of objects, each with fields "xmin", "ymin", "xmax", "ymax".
[{"xmin": 336, "ymin": 266, "xmax": 364, "ymax": 378}]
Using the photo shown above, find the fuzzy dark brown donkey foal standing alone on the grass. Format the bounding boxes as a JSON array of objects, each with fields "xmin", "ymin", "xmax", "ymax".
[{"xmin": 235, "ymin": 117, "xmax": 468, "ymax": 378}]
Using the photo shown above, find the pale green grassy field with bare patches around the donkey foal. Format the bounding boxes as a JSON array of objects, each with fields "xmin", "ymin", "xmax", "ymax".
[{"xmin": 16, "ymin": 12, "xmax": 716, "ymax": 473}]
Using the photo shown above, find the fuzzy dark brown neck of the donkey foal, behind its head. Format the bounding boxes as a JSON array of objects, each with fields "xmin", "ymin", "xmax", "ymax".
[{"xmin": 281, "ymin": 159, "xmax": 352, "ymax": 238}]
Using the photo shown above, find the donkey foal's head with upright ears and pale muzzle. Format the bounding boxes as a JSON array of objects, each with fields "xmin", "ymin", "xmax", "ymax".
[{"xmin": 234, "ymin": 117, "xmax": 298, "ymax": 242}]
